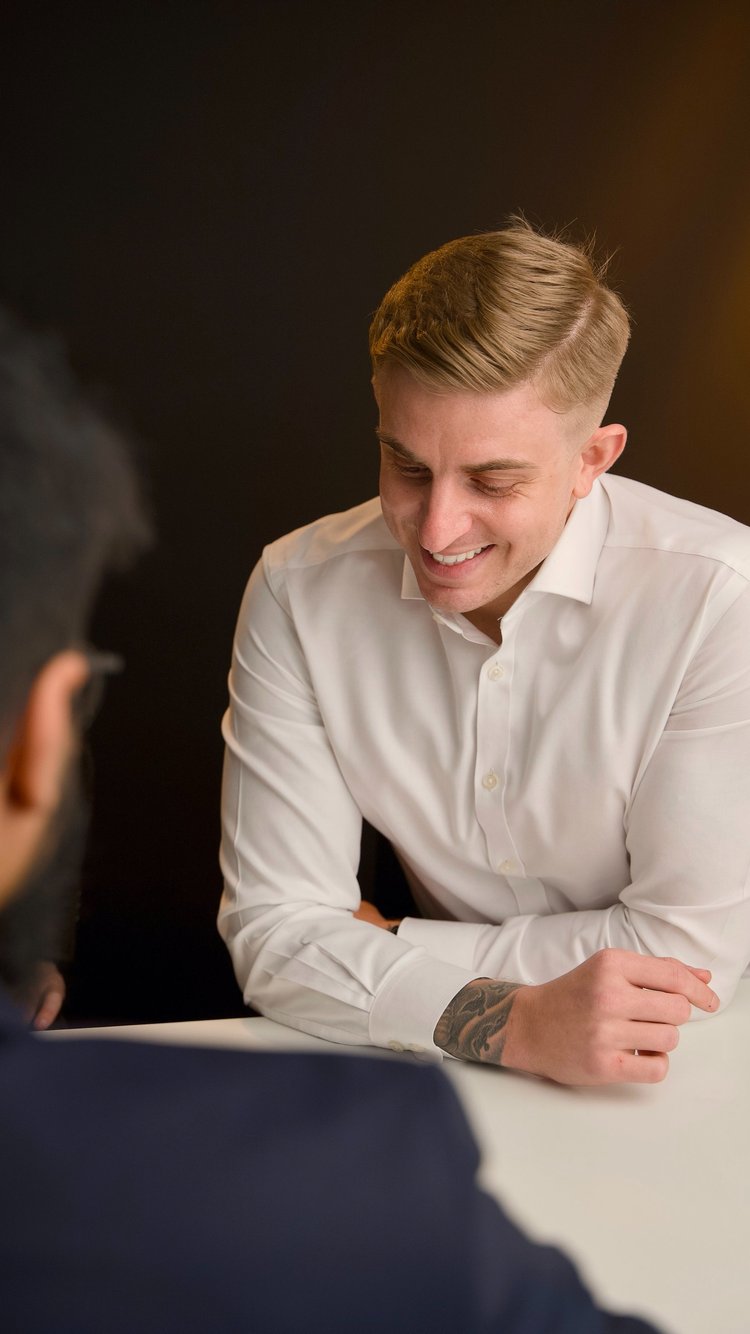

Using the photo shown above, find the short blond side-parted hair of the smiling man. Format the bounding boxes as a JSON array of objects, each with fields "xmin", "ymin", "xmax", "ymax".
[{"xmin": 370, "ymin": 217, "xmax": 630, "ymax": 414}]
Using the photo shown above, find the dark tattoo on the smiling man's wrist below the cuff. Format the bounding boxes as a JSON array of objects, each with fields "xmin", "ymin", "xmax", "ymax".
[{"xmin": 434, "ymin": 978, "xmax": 520, "ymax": 1066}]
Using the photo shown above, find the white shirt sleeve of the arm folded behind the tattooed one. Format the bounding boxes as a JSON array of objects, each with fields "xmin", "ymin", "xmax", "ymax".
[{"xmin": 399, "ymin": 590, "xmax": 750, "ymax": 1005}]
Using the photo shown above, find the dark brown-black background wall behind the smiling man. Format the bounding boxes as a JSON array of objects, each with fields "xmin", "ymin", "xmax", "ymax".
[{"xmin": 0, "ymin": 0, "xmax": 750, "ymax": 1021}]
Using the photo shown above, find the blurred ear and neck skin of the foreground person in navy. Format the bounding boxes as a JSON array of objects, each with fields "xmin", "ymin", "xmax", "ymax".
[{"xmin": 0, "ymin": 650, "xmax": 88, "ymax": 902}]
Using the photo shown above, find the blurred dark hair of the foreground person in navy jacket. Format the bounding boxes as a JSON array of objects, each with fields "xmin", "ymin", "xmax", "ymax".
[{"xmin": 0, "ymin": 309, "xmax": 148, "ymax": 739}]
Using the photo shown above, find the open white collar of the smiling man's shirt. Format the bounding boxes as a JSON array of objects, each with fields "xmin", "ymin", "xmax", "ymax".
[{"xmin": 402, "ymin": 480, "xmax": 610, "ymax": 620}]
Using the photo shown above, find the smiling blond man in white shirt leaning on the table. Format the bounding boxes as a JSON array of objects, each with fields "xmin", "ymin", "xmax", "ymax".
[{"xmin": 220, "ymin": 221, "xmax": 750, "ymax": 1083}]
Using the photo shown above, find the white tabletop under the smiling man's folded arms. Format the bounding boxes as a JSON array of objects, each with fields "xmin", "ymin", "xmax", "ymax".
[{"xmin": 46, "ymin": 978, "xmax": 750, "ymax": 1334}]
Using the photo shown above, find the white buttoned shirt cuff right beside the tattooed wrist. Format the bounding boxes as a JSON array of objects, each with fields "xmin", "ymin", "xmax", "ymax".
[{"xmin": 370, "ymin": 949, "xmax": 476, "ymax": 1061}]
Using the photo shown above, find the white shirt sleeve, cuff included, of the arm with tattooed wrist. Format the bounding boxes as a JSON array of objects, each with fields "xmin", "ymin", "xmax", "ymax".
[{"xmin": 219, "ymin": 552, "xmax": 474, "ymax": 1061}]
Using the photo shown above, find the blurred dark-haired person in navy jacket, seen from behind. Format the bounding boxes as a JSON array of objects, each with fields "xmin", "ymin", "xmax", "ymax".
[{"xmin": 0, "ymin": 306, "xmax": 646, "ymax": 1334}]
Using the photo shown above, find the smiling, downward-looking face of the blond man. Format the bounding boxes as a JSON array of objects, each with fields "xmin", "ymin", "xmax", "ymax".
[{"xmin": 375, "ymin": 366, "xmax": 611, "ymax": 634}]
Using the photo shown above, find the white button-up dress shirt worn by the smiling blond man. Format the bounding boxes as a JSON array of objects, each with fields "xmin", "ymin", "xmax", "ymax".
[{"xmin": 219, "ymin": 476, "xmax": 750, "ymax": 1058}]
